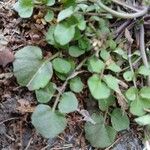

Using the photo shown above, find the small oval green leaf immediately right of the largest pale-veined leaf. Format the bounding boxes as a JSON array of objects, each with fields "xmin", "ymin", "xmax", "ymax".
[{"xmin": 52, "ymin": 58, "xmax": 71, "ymax": 74}]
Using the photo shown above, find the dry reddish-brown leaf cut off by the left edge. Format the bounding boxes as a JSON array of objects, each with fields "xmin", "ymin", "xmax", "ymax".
[{"xmin": 0, "ymin": 47, "xmax": 14, "ymax": 67}]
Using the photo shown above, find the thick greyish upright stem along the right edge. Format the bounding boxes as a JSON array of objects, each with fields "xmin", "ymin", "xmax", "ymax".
[{"xmin": 139, "ymin": 25, "xmax": 150, "ymax": 86}]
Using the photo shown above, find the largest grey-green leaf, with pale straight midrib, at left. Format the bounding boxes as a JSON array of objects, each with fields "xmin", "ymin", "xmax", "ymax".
[{"xmin": 13, "ymin": 46, "xmax": 53, "ymax": 90}]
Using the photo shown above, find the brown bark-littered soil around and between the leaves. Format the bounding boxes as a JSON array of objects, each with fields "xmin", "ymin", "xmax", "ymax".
[{"xmin": 0, "ymin": 0, "xmax": 146, "ymax": 150}]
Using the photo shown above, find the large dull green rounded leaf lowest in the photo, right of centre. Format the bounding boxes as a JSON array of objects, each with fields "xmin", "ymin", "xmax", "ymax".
[{"xmin": 84, "ymin": 114, "xmax": 116, "ymax": 148}]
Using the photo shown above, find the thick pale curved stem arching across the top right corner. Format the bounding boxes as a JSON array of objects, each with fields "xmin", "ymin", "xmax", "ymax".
[{"xmin": 94, "ymin": 0, "xmax": 148, "ymax": 19}]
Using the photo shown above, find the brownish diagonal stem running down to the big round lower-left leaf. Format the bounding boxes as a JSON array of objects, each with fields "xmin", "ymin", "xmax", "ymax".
[{"xmin": 52, "ymin": 57, "xmax": 88, "ymax": 112}]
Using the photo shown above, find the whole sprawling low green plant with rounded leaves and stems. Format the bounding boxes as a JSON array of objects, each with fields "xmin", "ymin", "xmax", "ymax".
[{"xmin": 13, "ymin": 0, "xmax": 150, "ymax": 148}]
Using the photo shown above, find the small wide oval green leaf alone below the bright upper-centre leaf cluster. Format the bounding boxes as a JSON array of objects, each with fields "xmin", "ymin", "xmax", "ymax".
[{"xmin": 69, "ymin": 46, "xmax": 85, "ymax": 57}]
